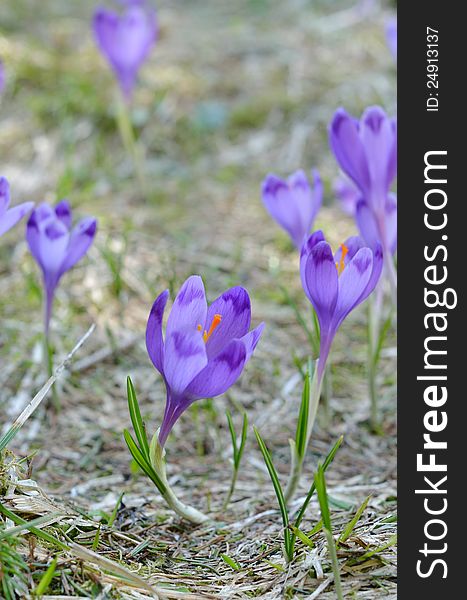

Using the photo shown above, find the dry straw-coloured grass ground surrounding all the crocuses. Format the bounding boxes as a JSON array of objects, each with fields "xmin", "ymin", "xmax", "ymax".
[{"xmin": 0, "ymin": 0, "xmax": 396, "ymax": 600}]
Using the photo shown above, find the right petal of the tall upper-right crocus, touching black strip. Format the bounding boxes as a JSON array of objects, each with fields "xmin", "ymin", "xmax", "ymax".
[{"xmin": 361, "ymin": 106, "xmax": 396, "ymax": 207}]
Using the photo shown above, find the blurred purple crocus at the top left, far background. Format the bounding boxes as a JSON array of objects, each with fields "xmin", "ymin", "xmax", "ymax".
[{"xmin": 93, "ymin": 0, "xmax": 157, "ymax": 99}]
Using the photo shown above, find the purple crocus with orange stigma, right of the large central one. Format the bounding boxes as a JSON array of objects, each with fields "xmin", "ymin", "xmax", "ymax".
[{"xmin": 300, "ymin": 231, "xmax": 383, "ymax": 382}]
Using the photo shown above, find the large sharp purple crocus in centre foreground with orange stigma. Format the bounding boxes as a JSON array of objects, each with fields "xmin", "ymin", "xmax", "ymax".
[{"xmin": 146, "ymin": 275, "xmax": 264, "ymax": 447}]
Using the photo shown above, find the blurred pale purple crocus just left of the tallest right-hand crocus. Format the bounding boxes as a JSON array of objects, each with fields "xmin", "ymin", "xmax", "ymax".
[{"xmin": 261, "ymin": 170, "xmax": 323, "ymax": 250}]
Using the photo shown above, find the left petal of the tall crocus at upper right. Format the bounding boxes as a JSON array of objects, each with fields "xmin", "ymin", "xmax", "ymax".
[{"xmin": 329, "ymin": 108, "xmax": 370, "ymax": 193}]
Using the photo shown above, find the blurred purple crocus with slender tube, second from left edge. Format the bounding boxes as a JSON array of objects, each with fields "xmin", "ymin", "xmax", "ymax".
[{"xmin": 26, "ymin": 200, "xmax": 97, "ymax": 335}]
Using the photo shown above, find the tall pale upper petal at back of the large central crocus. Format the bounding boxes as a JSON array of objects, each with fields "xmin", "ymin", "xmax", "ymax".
[{"xmin": 166, "ymin": 275, "xmax": 207, "ymax": 337}]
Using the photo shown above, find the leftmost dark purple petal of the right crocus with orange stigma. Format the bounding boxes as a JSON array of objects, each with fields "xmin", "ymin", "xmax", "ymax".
[{"xmin": 300, "ymin": 242, "xmax": 338, "ymax": 332}]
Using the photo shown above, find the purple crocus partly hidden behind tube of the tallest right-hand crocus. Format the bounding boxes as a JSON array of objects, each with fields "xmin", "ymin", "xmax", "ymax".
[{"xmin": 334, "ymin": 177, "xmax": 397, "ymax": 254}]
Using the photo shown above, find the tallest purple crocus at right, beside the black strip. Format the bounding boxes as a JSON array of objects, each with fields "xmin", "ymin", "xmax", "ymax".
[{"xmin": 329, "ymin": 106, "xmax": 397, "ymax": 255}]
